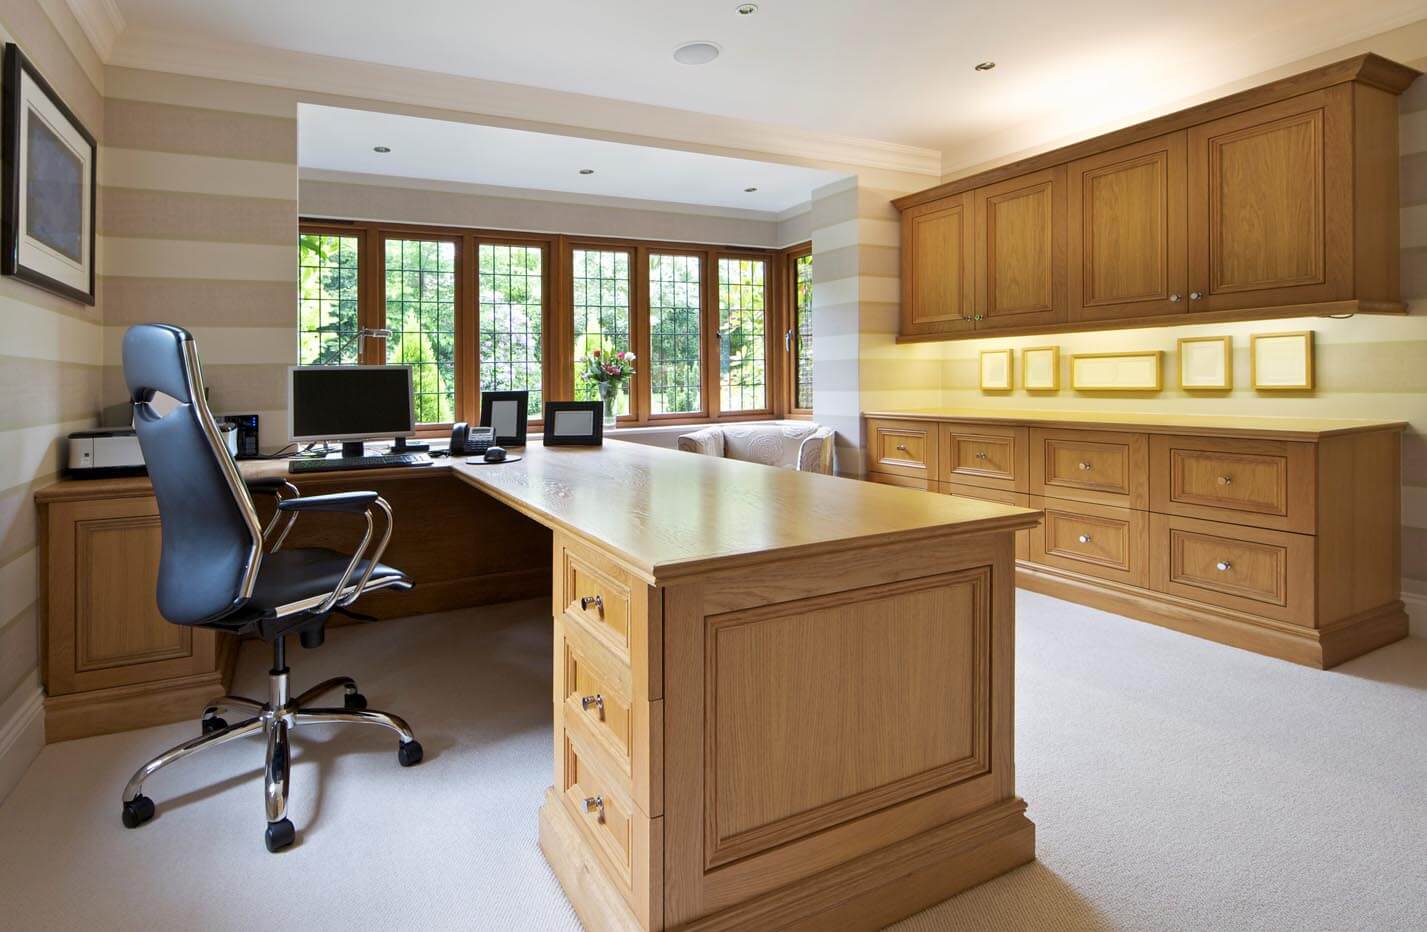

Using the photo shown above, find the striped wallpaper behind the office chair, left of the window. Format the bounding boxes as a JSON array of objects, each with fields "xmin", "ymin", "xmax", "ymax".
[{"xmin": 98, "ymin": 69, "xmax": 297, "ymax": 445}]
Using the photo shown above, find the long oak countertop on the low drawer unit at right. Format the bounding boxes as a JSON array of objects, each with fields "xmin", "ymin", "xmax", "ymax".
[{"xmin": 863, "ymin": 404, "xmax": 1407, "ymax": 440}]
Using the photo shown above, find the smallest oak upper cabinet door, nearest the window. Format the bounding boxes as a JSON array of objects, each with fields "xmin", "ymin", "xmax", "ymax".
[{"xmin": 902, "ymin": 194, "xmax": 976, "ymax": 334}]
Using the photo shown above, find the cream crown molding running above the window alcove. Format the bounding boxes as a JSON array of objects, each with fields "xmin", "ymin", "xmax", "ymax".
[{"xmin": 105, "ymin": 26, "xmax": 942, "ymax": 180}]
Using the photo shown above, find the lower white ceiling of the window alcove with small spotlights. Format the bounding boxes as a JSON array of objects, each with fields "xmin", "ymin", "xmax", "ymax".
[{"xmin": 297, "ymin": 104, "xmax": 842, "ymax": 213}]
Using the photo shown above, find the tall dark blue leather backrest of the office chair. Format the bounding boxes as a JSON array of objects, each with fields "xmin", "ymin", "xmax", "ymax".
[{"xmin": 124, "ymin": 324, "xmax": 263, "ymax": 625}]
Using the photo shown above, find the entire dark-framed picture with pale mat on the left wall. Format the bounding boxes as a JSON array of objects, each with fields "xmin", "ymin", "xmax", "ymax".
[{"xmin": 0, "ymin": 43, "xmax": 98, "ymax": 304}]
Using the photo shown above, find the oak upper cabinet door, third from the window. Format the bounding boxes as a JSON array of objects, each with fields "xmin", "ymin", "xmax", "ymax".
[{"xmin": 1067, "ymin": 133, "xmax": 1189, "ymax": 321}]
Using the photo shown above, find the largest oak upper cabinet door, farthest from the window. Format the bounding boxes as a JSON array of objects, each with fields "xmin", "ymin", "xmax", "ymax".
[{"xmin": 1189, "ymin": 86, "xmax": 1353, "ymax": 311}]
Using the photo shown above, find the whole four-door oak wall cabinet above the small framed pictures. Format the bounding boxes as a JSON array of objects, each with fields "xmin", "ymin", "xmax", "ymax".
[{"xmin": 895, "ymin": 56, "xmax": 1418, "ymax": 340}]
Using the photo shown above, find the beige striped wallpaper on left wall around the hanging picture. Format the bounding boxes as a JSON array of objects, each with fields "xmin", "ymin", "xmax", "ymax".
[{"xmin": 0, "ymin": 0, "xmax": 106, "ymax": 799}]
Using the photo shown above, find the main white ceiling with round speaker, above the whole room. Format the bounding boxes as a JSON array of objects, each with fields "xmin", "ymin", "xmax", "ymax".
[{"xmin": 117, "ymin": 0, "xmax": 1423, "ymax": 151}]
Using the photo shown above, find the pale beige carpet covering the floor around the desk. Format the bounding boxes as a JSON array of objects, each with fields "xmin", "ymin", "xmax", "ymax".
[{"xmin": 0, "ymin": 592, "xmax": 1427, "ymax": 932}]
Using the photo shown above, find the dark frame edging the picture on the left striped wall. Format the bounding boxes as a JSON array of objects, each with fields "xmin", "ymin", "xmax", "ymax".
[{"xmin": 0, "ymin": 43, "xmax": 98, "ymax": 305}]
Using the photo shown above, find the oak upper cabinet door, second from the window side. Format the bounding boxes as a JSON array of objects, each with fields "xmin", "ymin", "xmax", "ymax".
[{"xmin": 976, "ymin": 166, "xmax": 1066, "ymax": 330}]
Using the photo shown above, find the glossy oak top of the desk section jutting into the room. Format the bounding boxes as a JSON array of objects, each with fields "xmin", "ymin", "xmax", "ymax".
[{"xmin": 451, "ymin": 440, "xmax": 1040, "ymax": 581}]
